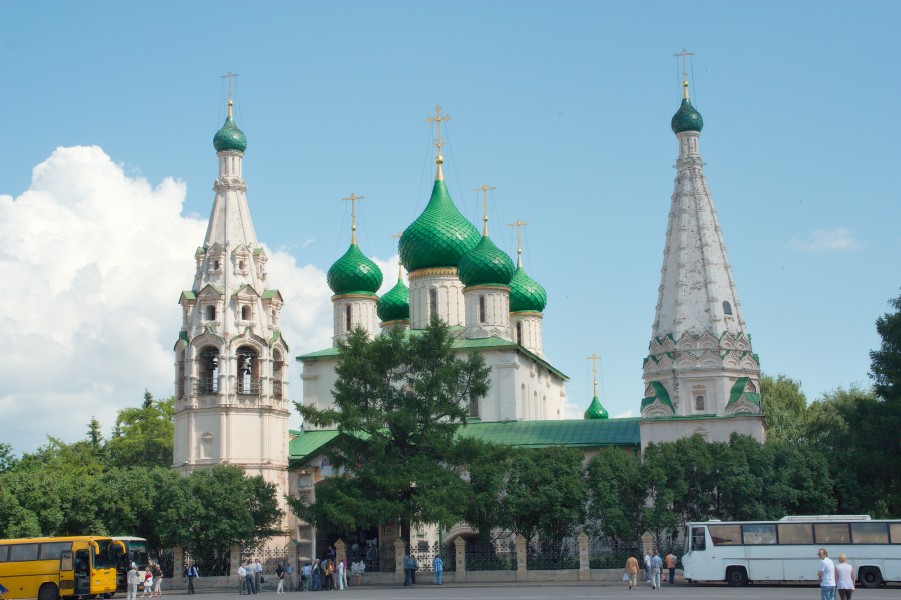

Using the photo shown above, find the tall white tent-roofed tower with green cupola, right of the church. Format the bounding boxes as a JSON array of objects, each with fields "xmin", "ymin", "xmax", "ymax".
[{"xmin": 641, "ymin": 63, "xmax": 763, "ymax": 434}]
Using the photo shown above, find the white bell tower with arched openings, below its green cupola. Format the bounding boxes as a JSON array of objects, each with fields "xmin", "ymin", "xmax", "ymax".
[{"xmin": 173, "ymin": 141, "xmax": 291, "ymax": 508}]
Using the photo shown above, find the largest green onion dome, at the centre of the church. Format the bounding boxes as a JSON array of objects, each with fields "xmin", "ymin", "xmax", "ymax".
[{"xmin": 398, "ymin": 180, "xmax": 479, "ymax": 272}]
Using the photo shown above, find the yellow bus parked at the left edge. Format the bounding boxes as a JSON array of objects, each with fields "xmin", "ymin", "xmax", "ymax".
[{"xmin": 0, "ymin": 535, "xmax": 125, "ymax": 600}]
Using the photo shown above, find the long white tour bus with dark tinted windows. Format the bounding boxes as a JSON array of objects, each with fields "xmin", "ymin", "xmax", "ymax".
[{"xmin": 682, "ymin": 515, "xmax": 901, "ymax": 587}]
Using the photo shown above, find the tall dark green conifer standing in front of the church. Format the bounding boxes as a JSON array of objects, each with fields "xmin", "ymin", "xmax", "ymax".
[{"xmin": 289, "ymin": 319, "xmax": 489, "ymax": 540}]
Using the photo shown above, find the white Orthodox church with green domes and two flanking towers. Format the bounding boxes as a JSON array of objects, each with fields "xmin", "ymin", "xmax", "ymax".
[{"xmin": 174, "ymin": 68, "xmax": 765, "ymax": 556}]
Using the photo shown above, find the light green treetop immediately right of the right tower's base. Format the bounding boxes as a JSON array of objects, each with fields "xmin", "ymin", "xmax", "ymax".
[{"xmin": 760, "ymin": 373, "xmax": 808, "ymax": 445}]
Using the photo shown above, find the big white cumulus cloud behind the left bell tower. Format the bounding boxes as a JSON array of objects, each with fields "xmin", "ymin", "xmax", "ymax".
[{"xmin": 0, "ymin": 146, "xmax": 331, "ymax": 452}]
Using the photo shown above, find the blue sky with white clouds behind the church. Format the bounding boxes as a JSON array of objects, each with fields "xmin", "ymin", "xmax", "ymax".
[{"xmin": 0, "ymin": 1, "xmax": 901, "ymax": 451}]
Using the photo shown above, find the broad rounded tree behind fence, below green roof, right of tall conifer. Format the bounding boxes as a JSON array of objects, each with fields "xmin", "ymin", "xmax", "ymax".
[{"xmin": 504, "ymin": 446, "xmax": 588, "ymax": 542}]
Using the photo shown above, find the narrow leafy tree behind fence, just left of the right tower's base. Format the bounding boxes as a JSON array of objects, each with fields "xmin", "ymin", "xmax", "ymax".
[{"xmin": 587, "ymin": 448, "xmax": 647, "ymax": 544}]
